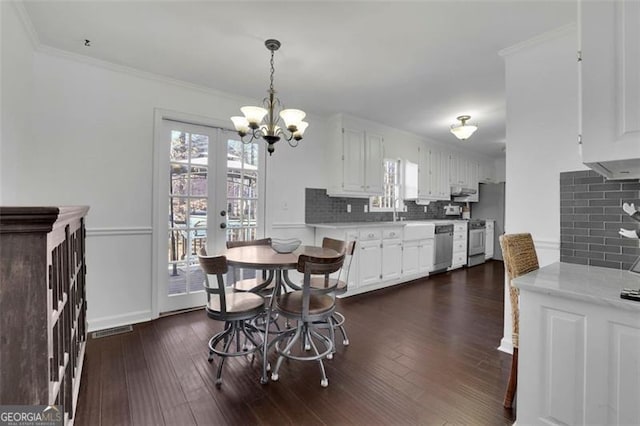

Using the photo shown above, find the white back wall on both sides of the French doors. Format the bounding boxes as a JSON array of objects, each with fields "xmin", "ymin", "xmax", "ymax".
[{"xmin": 9, "ymin": 34, "xmax": 324, "ymax": 329}]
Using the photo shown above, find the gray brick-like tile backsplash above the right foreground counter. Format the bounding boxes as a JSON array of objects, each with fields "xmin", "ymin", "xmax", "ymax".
[{"xmin": 560, "ymin": 170, "xmax": 640, "ymax": 270}]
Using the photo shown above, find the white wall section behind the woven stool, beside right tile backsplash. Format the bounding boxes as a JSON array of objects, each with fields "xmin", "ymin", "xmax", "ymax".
[{"xmin": 501, "ymin": 26, "xmax": 586, "ymax": 350}]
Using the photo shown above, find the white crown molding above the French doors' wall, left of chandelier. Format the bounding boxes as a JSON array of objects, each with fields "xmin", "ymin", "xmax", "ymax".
[{"xmin": 36, "ymin": 44, "xmax": 250, "ymax": 103}]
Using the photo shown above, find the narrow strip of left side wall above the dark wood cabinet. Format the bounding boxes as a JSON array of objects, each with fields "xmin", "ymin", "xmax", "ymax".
[{"xmin": 0, "ymin": 1, "xmax": 34, "ymax": 205}]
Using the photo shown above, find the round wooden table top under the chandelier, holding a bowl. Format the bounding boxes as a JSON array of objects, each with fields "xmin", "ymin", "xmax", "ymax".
[{"xmin": 222, "ymin": 246, "xmax": 338, "ymax": 269}]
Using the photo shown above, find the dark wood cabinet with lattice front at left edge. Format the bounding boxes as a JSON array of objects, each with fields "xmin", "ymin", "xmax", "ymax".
[{"xmin": 0, "ymin": 206, "xmax": 89, "ymax": 423}]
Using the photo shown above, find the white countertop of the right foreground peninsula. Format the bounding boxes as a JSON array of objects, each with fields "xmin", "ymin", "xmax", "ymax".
[{"xmin": 513, "ymin": 262, "xmax": 640, "ymax": 312}]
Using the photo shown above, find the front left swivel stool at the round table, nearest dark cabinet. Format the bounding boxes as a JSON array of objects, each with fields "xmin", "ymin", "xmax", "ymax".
[{"xmin": 198, "ymin": 248, "xmax": 265, "ymax": 387}]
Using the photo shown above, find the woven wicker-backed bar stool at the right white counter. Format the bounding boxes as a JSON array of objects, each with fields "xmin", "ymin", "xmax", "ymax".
[{"xmin": 499, "ymin": 234, "xmax": 539, "ymax": 408}]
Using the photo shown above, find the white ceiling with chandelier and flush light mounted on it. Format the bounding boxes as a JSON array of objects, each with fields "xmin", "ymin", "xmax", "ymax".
[{"xmin": 23, "ymin": 0, "xmax": 576, "ymax": 157}]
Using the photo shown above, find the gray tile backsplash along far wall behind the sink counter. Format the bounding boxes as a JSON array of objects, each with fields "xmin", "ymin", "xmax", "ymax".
[{"xmin": 305, "ymin": 188, "xmax": 464, "ymax": 223}]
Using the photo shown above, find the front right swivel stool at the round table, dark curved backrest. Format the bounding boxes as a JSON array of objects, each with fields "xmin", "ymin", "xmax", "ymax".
[{"xmin": 271, "ymin": 253, "xmax": 345, "ymax": 387}]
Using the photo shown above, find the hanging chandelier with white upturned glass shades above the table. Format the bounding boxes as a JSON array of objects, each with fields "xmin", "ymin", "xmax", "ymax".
[{"xmin": 231, "ymin": 39, "xmax": 309, "ymax": 155}]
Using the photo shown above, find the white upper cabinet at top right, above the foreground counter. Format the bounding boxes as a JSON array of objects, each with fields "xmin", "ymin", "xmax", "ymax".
[{"xmin": 579, "ymin": 0, "xmax": 640, "ymax": 179}]
